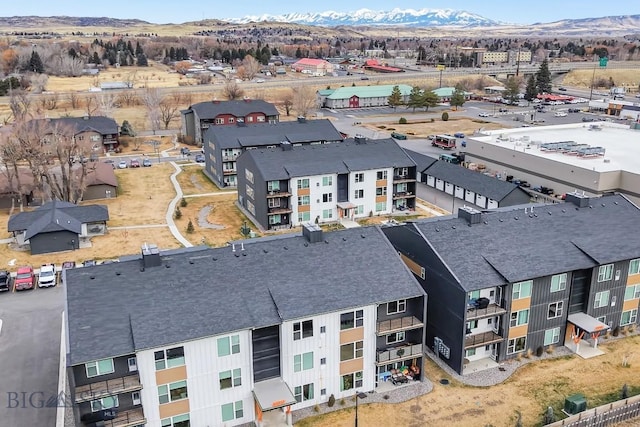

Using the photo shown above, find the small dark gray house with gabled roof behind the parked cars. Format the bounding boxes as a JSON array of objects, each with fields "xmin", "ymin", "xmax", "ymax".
[{"xmin": 7, "ymin": 200, "xmax": 109, "ymax": 255}]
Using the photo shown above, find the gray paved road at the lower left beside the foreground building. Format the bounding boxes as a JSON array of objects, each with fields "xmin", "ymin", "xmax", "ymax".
[{"xmin": 0, "ymin": 285, "xmax": 64, "ymax": 427}]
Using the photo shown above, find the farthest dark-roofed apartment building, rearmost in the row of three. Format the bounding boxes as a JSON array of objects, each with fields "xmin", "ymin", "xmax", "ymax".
[{"xmin": 180, "ymin": 99, "xmax": 280, "ymax": 146}]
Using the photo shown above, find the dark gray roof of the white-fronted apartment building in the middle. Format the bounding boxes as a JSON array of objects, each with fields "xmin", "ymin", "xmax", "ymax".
[{"xmin": 238, "ymin": 138, "xmax": 415, "ymax": 181}]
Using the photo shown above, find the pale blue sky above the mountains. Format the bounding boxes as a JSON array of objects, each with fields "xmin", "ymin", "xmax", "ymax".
[{"xmin": 0, "ymin": 0, "xmax": 640, "ymax": 24}]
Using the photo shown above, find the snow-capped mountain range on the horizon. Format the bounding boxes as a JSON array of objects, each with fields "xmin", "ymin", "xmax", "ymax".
[{"xmin": 223, "ymin": 8, "xmax": 500, "ymax": 27}]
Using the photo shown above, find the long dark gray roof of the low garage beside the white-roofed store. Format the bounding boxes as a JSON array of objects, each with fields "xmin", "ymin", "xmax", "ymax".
[{"xmin": 423, "ymin": 160, "xmax": 524, "ymax": 202}]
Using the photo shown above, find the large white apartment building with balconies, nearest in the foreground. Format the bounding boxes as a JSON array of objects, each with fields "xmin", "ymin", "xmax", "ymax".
[{"xmin": 65, "ymin": 225, "xmax": 426, "ymax": 427}]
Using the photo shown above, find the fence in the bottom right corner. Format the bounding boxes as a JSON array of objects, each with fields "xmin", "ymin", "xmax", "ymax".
[{"xmin": 547, "ymin": 395, "xmax": 640, "ymax": 427}]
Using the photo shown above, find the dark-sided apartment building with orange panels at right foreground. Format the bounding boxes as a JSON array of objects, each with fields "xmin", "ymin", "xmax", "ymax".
[{"xmin": 383, "ymin": 194, "xmax": 640, "ymax": 374}]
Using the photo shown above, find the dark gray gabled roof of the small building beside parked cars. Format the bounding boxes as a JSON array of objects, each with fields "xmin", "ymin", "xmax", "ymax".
[{"xmin": 7, "ymin": 200, "xmax": 109, "ymax": 239}]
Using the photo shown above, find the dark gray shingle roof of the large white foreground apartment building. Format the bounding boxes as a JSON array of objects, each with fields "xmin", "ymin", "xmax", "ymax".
[{"xmin": 65, "ymin": 227, "xmax": 424, "ymax": 365}]
